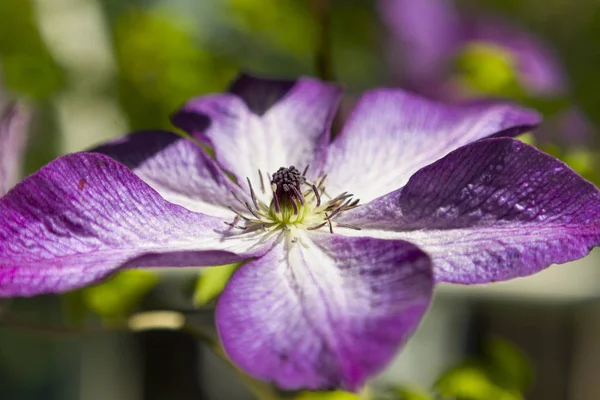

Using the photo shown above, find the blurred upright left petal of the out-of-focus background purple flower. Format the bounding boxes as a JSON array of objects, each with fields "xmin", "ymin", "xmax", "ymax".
[{"xmin": 378, "ymin": 0, "xmax": 462, "ymax": 88}]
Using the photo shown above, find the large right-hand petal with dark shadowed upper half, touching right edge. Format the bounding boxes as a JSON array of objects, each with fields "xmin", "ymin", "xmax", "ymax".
[{"xmin": 338, "ymin": 138, "xmax": 600, "ymax": 284}]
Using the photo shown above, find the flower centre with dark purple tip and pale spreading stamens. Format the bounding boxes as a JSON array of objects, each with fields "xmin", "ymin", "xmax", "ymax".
[{"xmin": 226, "ymin": 166, "xmax": 360, "ymax": 241}]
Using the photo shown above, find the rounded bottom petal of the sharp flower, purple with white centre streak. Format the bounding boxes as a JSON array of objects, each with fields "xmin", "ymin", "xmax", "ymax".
[{"xmin": 216, "ymin": 233, "xmax": 432, "ymax": 390}]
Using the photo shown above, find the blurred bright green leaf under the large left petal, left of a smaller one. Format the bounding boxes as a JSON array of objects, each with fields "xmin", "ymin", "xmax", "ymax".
[{"xmin": 82, "ymin": 269, "xmax": 158, "ymax": 319}]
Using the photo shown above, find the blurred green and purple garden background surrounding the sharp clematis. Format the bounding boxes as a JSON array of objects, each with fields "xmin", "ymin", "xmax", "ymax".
[{"xmin": 0, "ymin": 0, "xmax": 600, "ymax": 400}]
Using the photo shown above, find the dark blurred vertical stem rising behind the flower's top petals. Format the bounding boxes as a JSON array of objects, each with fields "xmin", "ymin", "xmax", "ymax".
[{"xmin": 311, "ymin": 0, "xmax": 334, "ymax": 81}]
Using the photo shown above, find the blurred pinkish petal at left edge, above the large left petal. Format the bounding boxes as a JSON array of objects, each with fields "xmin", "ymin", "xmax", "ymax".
[{"xmin": 0, "ymin": 104, "xmax": 29, "ymax": 196}]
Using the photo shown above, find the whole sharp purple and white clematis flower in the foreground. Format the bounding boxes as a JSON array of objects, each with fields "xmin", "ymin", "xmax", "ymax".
[{"xmin": 0, "ymin": 76, "xmax": 600, "ymax": 390}]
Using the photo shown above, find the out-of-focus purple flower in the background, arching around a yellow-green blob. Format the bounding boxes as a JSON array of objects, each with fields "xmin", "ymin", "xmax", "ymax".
[{"xmin": 379, "ymin": 0, "xmax": 565, "ymax": 97}]
